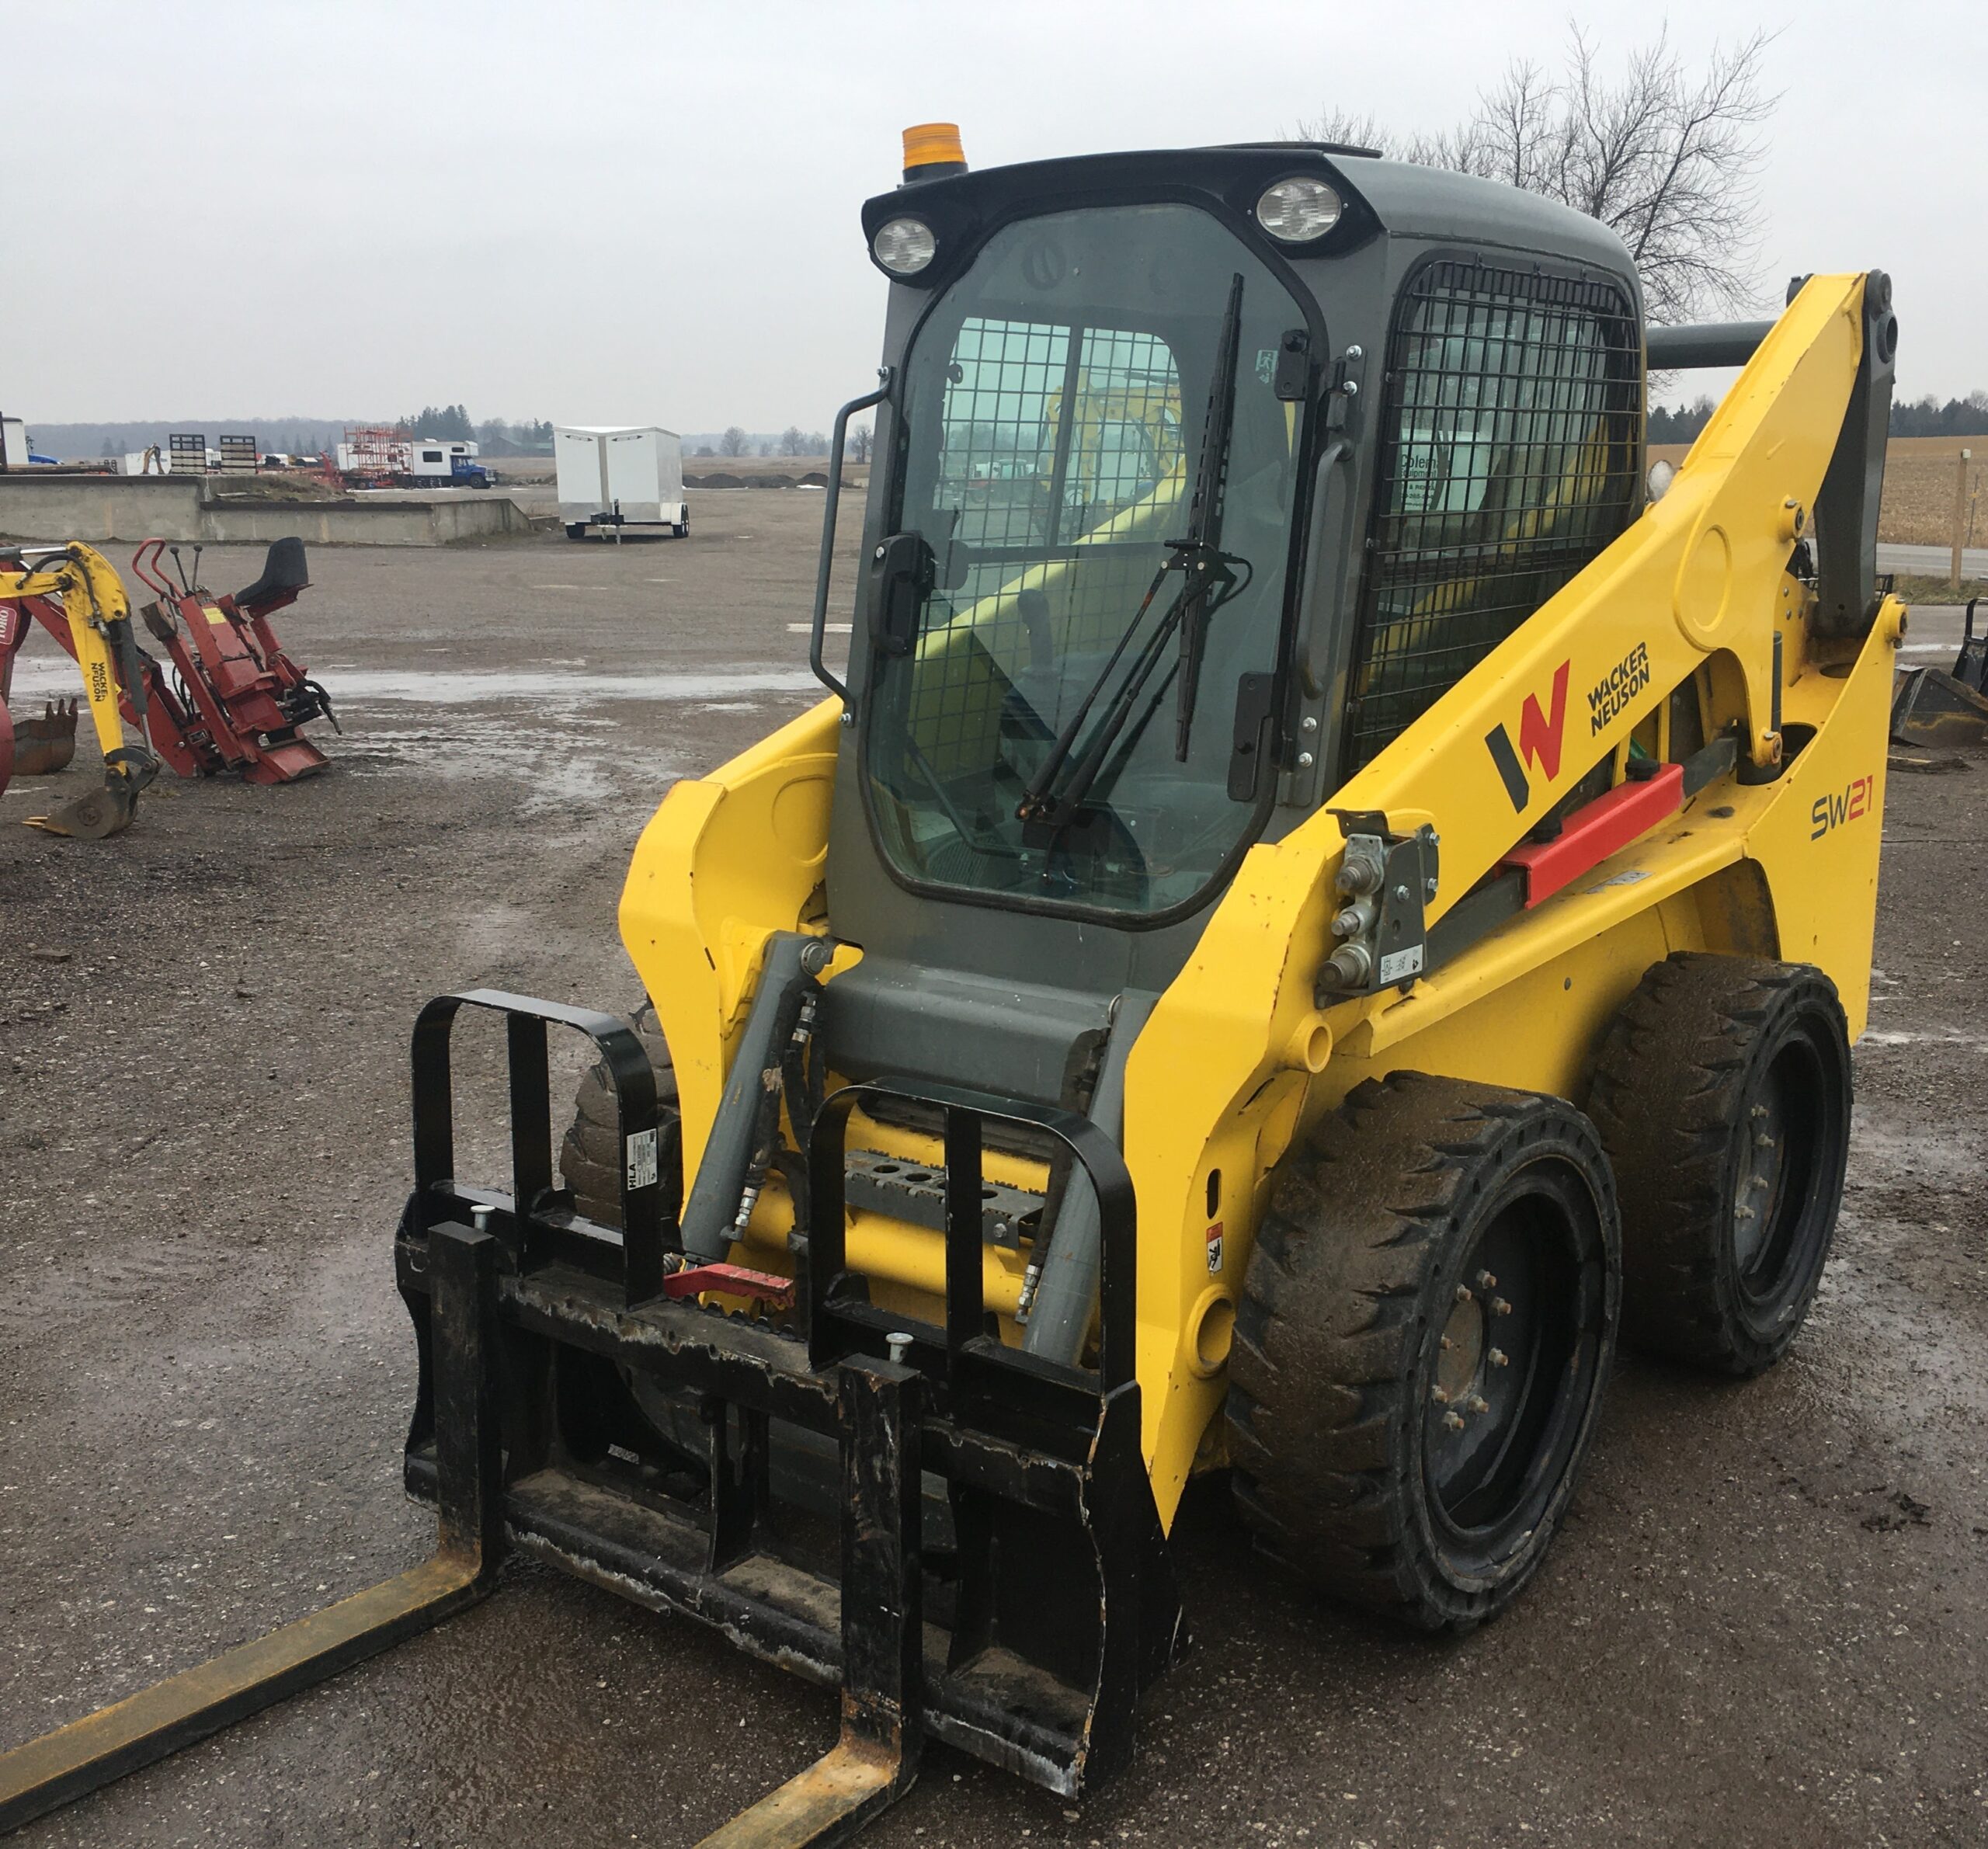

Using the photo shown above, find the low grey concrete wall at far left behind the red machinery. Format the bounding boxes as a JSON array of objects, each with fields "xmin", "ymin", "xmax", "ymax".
[{"xmin": 0, "ymin": 471, "xmax": 533, "ymax": 544}]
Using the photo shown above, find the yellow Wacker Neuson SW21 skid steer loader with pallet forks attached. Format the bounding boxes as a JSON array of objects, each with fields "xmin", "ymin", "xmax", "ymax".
[{"xmin": 0, "ymin": 127, "xmax": 1904, "ymax": 1845}]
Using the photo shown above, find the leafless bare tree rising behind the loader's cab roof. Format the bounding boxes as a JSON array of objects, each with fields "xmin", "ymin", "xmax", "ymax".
[{"xmin": 1298, "ymin": 28, "xmax": 1779, "ymax": 322}]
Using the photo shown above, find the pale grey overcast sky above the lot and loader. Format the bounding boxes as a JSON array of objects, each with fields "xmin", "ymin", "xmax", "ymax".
[{"xmin": 0, "ymin": 0, "xmax": 1988, "ymax": 429}]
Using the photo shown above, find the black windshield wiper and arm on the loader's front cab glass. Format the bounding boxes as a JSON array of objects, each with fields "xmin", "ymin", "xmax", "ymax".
[{"xmin": 1016, "ymin": 273, "xmax": 1242, "ymax": 827}]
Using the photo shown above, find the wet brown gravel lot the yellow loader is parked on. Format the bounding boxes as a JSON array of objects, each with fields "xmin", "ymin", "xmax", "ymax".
[{"xmin": 0, "ymin": 491, "xmax": 1988, "ymax": 1849}]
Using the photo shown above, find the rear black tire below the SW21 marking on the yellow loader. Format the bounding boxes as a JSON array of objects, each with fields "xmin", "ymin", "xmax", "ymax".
[{"xmin": 1588, "ymin": 952, "xmax": 1851, "ymax": 1376}]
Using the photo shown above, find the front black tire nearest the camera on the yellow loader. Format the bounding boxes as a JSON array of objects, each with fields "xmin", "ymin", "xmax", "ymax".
[{"xmin": 1229, "ymin": 1072, "xmax": 1620, "ymax": 1630}]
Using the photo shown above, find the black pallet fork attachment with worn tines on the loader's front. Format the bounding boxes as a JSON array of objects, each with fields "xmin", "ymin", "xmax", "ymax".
[{"xmin": 0, "ymin": 990, "xmax": 1183, "ymax": 1849}]
